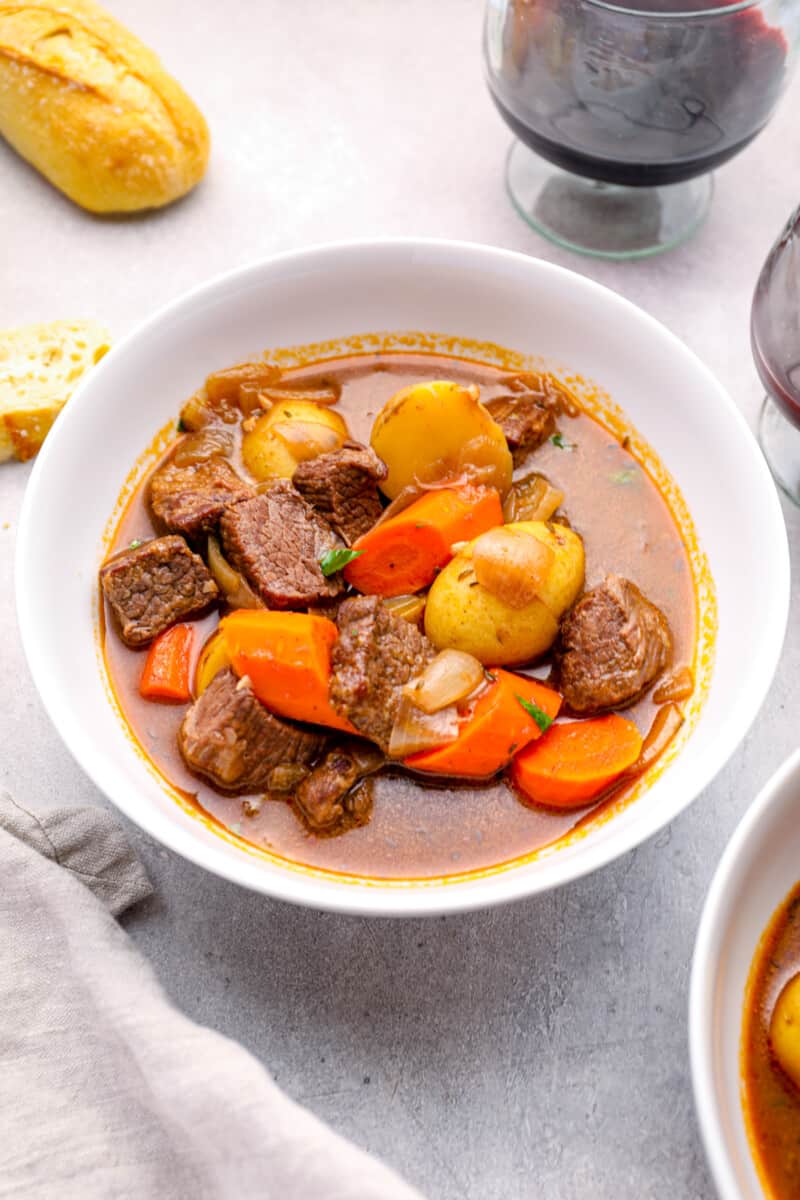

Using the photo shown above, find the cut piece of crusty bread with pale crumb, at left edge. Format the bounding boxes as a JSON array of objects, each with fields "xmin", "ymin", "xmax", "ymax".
[{"xmin": 0, "ymin": 320, "xmax": 110, "ymax": 462}]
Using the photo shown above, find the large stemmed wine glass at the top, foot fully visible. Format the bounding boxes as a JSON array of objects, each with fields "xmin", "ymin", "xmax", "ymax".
[{"xmin": 485, "ymin": 0, "xmax": 800, "ymax": 258}]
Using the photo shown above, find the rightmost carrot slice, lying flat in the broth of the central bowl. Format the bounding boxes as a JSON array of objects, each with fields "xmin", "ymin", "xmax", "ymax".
[{"xmin": 511, "ymin": 713, "xmax": 642, "ymax": 809}]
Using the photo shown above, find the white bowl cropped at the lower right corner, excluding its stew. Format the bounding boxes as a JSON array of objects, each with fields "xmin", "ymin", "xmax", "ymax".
[{"xmin": 688, "ymin": 750, "xmax": 800, "ymax": 1200}]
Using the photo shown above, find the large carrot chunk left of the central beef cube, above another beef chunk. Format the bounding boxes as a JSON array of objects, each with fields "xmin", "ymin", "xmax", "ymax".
[{"xmin": 219, "ymin": 608, "xmax": 355, "ymax": 733}]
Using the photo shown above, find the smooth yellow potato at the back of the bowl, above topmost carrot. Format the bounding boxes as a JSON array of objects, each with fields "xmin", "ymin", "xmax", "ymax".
[{"xmin": 371, "ymin": 379, "xmax": 513, "ymax": 500}]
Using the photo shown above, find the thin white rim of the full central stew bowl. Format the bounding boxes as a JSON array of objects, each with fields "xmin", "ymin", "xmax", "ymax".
[{"xmin": 14, "ymin": 236, "xmax": 790, "ymax": 917}]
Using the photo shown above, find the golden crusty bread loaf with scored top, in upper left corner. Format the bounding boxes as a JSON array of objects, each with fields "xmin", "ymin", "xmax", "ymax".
[{"xmin": 0, "ymin": 0, "xmax": 209, "ymax": 212}]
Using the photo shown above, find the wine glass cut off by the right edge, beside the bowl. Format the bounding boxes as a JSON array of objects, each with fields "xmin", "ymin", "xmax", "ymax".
[{"xmin": 750, "ymin": 206, "xmax": 800, "ymax": 504}]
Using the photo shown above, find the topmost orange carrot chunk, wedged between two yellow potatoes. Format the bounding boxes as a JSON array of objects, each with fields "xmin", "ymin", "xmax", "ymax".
[{"xmin": 344, "ymin": 487, "xmax": 503, "ymax": 596}]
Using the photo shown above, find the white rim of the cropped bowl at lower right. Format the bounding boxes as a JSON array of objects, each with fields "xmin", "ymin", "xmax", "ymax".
[{"xmin": 687, "ymin": 748, "xmax": 800, "ymax": 1200}]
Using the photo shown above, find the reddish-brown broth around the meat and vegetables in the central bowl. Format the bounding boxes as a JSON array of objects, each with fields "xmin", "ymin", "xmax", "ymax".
[{"xmin": 103, "ymin": 352, "xmax": 696, "ymax": 878}]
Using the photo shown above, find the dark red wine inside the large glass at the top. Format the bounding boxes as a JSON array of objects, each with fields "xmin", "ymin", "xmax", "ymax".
[{"xmin": 486, "ymin": 0, "xmax": 788, "ymax": 187}]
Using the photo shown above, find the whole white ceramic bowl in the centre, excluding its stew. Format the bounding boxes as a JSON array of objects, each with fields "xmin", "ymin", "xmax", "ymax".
[{"xmin": 17, "ymin": 240, "xmax": 789, "ymax": 914}]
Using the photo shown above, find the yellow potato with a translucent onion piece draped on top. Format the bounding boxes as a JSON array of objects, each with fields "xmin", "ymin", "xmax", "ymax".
[{"xmin": 425, "ymin": 521, "xmax": 584, "ymax": 666}]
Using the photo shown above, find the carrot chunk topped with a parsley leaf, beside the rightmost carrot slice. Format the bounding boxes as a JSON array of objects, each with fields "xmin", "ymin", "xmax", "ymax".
[{"xmin": 404, "ymin": 670, "xmax": 561, "ymax": 779}]
